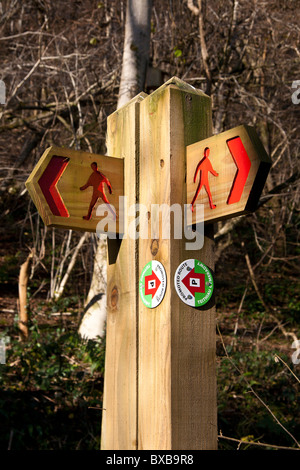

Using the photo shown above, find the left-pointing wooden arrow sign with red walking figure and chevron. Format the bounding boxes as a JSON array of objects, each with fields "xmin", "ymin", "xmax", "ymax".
[{"xmin": 25, "ymin": 147, "xmax": 124, "ymax": 233}]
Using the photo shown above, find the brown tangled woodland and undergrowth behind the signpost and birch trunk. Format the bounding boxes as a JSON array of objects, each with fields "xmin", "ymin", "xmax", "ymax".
[{"xmin": 0, "ymin": 0, "xmax": 300, "ymax": 450}]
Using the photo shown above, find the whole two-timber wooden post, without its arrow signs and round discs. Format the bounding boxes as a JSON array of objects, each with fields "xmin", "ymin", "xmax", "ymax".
[{"xmin": 101, "ymin": 78, "xmax": 217, "ymax": 450}]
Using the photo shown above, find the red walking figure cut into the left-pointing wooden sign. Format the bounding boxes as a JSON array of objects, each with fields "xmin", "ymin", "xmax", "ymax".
[{"xmin": 79, "ymin": 162, "xmax": 116, "ymax": 220}]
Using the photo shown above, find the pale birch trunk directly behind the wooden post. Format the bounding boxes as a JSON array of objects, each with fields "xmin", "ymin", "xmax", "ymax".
[{"xmin": 79, "ymin": 0, "xmax": 152, "ymax": 339}]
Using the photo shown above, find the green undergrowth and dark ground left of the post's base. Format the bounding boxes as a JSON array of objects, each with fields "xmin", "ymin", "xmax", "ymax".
[{"xmin": 0, "ymin": 322, "xmax": 105, "ymax": 450}]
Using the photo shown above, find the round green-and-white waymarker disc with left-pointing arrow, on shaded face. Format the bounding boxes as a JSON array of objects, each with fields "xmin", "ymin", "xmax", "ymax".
[{"xmin": 174, "ymin": 259, "xmax": 214, "ymax": 307}]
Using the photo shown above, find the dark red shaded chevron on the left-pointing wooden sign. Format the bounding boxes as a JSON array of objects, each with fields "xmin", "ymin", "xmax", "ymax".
[{"xmin": 38, "ymin": 155, "xmax": 69, "ymax": 217}]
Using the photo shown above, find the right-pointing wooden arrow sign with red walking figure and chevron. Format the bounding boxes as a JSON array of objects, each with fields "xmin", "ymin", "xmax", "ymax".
[{"xmin": 186, "ymin": 126, "xmax": 271, "ymax": 224}]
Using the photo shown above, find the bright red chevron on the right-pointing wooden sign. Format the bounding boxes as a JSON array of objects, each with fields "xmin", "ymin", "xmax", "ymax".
[{"xmin": 226, "ymin": 137, "xmax": 251, "ymax": 204}]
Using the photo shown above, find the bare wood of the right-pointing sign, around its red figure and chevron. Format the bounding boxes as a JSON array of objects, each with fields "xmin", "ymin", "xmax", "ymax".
[{"xmin": 187, "ymin": 125, "xmax": 271, "ymax": 223}]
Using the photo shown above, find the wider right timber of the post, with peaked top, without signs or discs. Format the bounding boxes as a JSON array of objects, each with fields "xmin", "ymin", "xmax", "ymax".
[{"xmin": 138, "ymin": 78, "xmax": 217, "ymax": 450}]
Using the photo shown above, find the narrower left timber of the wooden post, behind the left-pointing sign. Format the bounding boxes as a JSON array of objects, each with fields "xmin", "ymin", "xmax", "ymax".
[{"xmin": 101, "ymin": 93, "xmax": 147, "ymax": 450}]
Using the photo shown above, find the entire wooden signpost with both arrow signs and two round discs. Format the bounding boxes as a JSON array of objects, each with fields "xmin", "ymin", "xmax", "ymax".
[{"xmin": 27, "ymin": 78, "xmax": 270, "ymax": 450}]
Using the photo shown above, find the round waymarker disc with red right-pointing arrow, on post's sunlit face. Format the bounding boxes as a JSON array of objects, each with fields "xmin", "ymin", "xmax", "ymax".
[{"xmin": 139, "ymin": 260, "xmax": 167, "ymax": 308}]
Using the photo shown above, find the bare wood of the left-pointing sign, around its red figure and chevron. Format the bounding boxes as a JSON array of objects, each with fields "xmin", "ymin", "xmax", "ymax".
[{"xmin": 25, "ymin": 147, "xmax": 124, "ymax": 233}]
